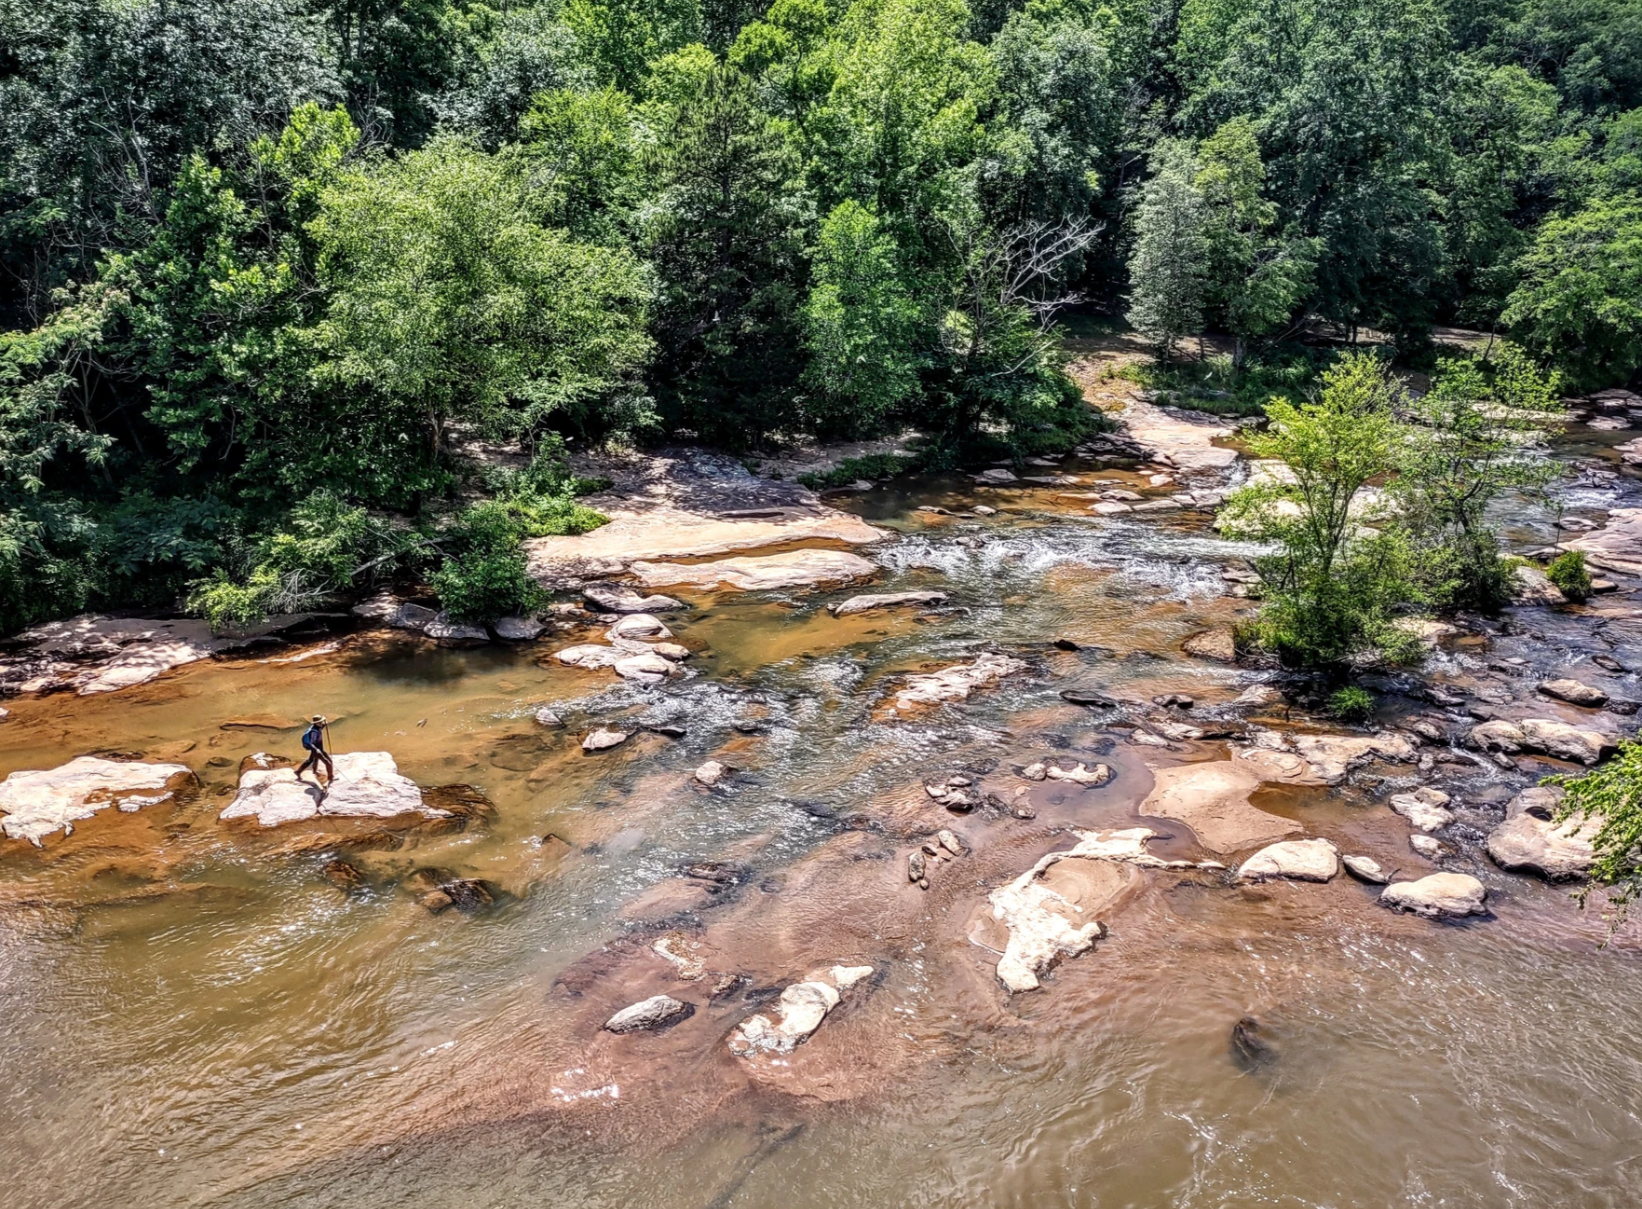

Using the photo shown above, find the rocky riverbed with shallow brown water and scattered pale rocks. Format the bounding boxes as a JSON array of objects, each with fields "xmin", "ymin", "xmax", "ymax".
[{"xmin": 0, "ymin": 365, "xmax": 1642, "ymax": 1206}]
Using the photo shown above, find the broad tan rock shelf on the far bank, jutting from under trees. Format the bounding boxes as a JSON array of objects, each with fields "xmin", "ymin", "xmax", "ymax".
[{"xmin": 524, "ymin": 448, "xmax": 885, "ymax": 586}]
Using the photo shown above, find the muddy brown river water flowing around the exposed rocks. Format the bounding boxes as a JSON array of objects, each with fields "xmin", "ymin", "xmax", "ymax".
[{"xmin": 0, "ymin": 463, "xmax": 1642, "ymax": 1209}]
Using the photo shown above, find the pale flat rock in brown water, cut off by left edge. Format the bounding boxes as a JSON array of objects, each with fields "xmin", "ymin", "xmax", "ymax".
[{"xmin": 0, "ymin": 756, "xmax": 194, "ymax": 848}]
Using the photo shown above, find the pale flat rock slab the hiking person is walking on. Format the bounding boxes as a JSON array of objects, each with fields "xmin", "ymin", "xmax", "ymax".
[{"xmin": 217, "ymin": 751, "xmax": 450, "ymax": 826}]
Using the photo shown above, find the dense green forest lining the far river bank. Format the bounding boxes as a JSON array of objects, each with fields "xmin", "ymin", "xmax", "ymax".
[{"xmin": 0, "ymin": 0, "xmax": 1642, "ymax": 632}]
